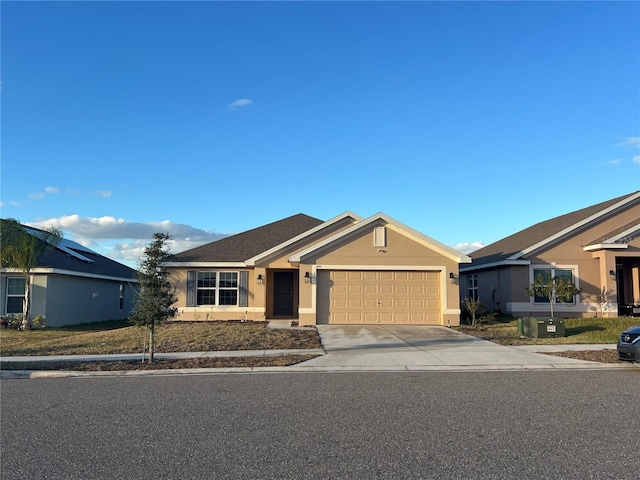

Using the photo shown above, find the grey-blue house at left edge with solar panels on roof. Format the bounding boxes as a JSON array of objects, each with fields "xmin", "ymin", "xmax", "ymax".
[{"xmin": 0, "ymin": 227, "xmax": 137, "ymax": 327}]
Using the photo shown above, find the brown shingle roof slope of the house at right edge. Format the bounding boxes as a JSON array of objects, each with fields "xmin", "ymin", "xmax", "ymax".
[{"xmin": 469, "ymin": 192, "xmax": 638, "ymax": 267}]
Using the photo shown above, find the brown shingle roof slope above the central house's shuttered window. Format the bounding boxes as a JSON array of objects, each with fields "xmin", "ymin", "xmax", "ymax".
[{"xmin": 173, "ymin": 213, "xmax": 324, "ymax": 262}]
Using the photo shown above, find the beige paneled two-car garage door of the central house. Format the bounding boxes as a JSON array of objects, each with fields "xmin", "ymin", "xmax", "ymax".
[{"xmin": 317, "ymin": 270, "xmax": 442, "ymax": 325}]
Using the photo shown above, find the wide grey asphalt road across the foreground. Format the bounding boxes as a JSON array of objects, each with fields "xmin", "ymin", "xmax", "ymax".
[{"xmin": 0, "ymin": 369, "xmax": 640, "ymax": 480}]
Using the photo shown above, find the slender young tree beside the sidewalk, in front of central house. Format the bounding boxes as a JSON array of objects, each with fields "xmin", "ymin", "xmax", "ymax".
[{"xmin": 131, "ymin": 233, "xmax": 178, "ymax": 363}]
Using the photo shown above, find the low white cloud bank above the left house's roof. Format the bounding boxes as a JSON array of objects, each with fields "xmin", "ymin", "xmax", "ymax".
[{"xmin": 28, "ymin": 215, "xmax": 226, "ymax": 267}]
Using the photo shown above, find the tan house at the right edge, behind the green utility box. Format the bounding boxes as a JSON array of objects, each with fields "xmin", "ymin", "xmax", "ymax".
[{"xmin": 460, "ymin": 191, "xmax": 640, "ymax": 318}]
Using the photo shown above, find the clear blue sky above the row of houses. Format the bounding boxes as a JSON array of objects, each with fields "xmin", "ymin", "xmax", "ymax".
[{"xmin": 0, "ymin": 1, "xmax": 640, "ymax": 265}]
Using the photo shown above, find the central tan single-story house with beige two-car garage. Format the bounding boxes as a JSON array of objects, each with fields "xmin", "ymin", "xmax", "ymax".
[{"xmin": 167, "ymin": 212, "xmax": 471, "ymax": 325}]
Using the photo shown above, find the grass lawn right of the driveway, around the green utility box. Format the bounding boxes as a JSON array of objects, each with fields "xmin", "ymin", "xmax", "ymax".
[{"xmin": 458, "ymin": 317, "xmax": 640, "ymax": 345}]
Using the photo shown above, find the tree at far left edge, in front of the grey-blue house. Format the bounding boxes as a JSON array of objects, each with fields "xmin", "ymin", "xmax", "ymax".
[{"xmin": 0, "ymin": 218, "xmax": 62, "ymax": 330}]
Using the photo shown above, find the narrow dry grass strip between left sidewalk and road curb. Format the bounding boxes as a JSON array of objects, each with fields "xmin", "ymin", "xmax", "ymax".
[{"xmin": 0, "ymin": 355, "xmax": 319, "ymax": 372}]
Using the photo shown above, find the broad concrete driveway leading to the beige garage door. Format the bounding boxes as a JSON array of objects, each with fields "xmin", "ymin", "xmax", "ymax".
[{"xmin": 290, "ymin": 325, "xmax": 602, "ymax": 371}]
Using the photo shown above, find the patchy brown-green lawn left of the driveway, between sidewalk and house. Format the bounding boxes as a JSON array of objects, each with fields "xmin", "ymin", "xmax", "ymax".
[{"xmin": 0, "ymin": 321, "xmax": 322, "ymax": 356}]
